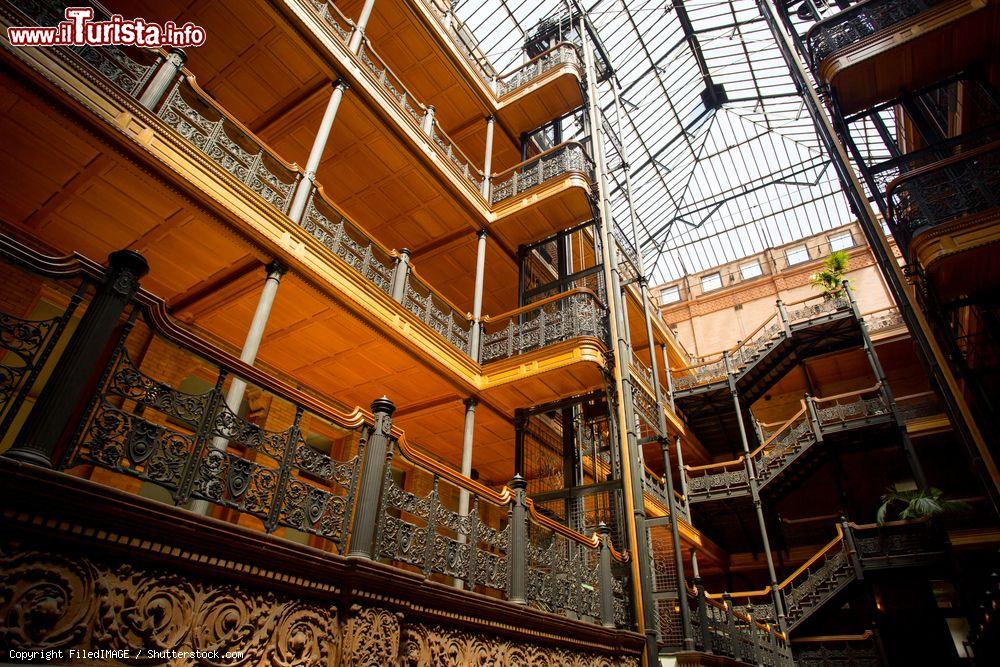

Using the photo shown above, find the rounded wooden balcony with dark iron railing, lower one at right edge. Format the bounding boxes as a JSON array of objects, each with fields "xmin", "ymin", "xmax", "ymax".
[{"xmin": 887, "ymin": 142, "xmax": 1000, "ymax": 300}]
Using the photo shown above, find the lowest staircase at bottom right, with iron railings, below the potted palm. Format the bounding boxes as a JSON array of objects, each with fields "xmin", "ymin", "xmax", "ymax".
[{"xmin": 707, "ymin": 521, "xmax": 943, "ymax": 631}]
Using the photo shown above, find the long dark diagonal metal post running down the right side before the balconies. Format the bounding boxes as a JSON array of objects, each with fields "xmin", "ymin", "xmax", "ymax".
[{"xmin": 757, "ymin": 0, "xmax": 1000, "ymax": 511}]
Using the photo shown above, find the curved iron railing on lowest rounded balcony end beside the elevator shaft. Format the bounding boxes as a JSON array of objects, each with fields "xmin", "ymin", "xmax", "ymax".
[{"xmin": 482, "ymin": 288, "xmax": 608, "ymax": 364}]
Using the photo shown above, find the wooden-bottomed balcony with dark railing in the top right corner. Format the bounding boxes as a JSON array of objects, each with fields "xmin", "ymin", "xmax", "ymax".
[{"xmin": 805, "ymin": 0, "xmax": 1000, "ymax": 114}]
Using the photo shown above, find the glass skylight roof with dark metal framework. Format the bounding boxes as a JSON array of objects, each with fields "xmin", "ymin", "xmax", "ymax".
[{"xmin": 455, "ymin": 0, "xmax": 860, "ymax": 284}]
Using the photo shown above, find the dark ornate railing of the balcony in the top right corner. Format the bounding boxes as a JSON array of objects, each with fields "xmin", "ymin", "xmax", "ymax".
[{"xmin": 805, "ymin": 0, "xmax": 941, "ymax": 71}]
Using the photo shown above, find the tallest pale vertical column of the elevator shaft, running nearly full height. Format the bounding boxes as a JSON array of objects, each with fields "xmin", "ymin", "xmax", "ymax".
[{"xmin": 580, "ymin": 28, "xmax": 658, "ymax": 666}]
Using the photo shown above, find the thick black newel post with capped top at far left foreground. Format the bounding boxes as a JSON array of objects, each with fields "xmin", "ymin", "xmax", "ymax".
[{"xmin": 6, "ymin": 250, "xmax": 149, "ymax": 468}]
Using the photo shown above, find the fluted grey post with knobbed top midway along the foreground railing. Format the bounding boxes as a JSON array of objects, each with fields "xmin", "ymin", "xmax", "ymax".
[{"xmin": 347, "ymin": 396, "xmax": 396, "ymax": 558}]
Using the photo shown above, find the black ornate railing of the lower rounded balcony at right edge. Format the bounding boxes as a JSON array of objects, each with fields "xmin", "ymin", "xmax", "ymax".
[{"xmin": 886, "ymin": 142, "xmax": 1000, "ymax": 254}]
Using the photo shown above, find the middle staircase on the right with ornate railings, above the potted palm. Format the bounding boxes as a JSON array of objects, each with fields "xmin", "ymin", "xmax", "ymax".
[{"xmin": 683, "ymin": 385, "xmax": 892, "ymax": 504}]
